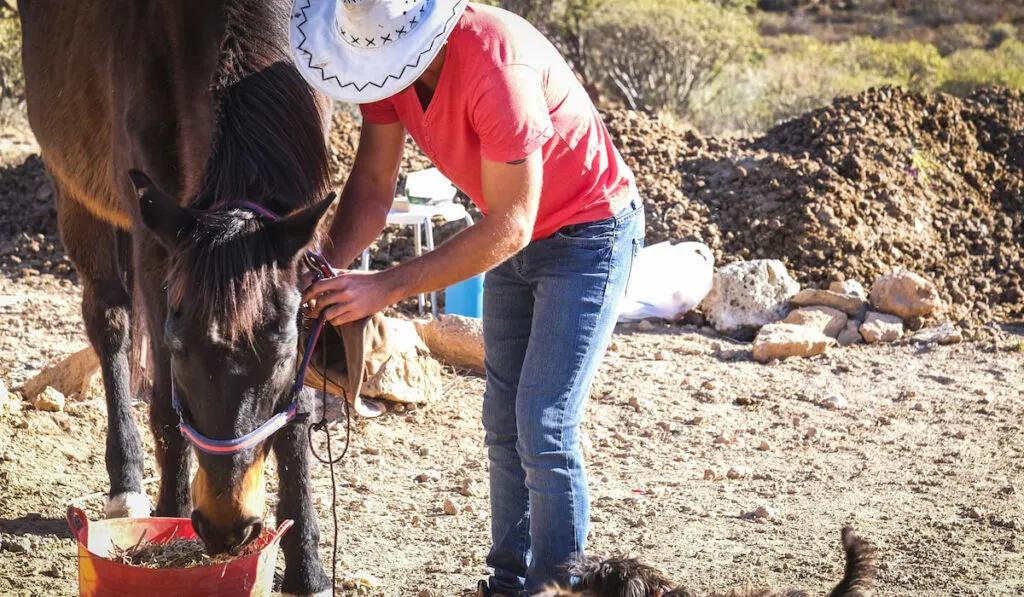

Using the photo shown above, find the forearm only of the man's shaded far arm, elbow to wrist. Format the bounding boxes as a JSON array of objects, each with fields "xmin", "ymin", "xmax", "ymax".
[{"xmin": 324, "ymin": 179, "xmax": 395, "ymax": 268}]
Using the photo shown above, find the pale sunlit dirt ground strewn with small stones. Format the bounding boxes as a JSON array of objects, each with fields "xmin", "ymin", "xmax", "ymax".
[{"xmin": 0, "ymin": 129, "xmax": 1024, "ymax": 597}]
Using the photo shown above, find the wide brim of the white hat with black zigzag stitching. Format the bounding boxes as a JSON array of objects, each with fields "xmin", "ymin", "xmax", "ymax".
[{"xmin": 291, "ymin": 0, "xmax": 467, "ymax": 103}]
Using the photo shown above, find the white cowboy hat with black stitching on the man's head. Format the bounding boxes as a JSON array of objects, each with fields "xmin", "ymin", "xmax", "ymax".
[{"xmin": 291, "ymin": 0, "xmax": 467, "ymax": 103}]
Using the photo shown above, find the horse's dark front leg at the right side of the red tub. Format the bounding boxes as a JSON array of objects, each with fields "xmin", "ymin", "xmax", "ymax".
[{"xmin": 273, "ymin": 391, "xmax": 331, "ymax": 596}]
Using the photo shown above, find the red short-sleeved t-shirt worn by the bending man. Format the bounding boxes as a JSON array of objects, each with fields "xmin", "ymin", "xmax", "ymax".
[{"xmin": 360, "ymin": 4, "xmax": 631, "ymax": 240}]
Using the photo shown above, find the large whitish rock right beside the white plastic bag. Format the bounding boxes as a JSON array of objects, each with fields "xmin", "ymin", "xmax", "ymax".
[{"xmin": 701, "ymin": 259, "xmax": 800, "ymax": 333}]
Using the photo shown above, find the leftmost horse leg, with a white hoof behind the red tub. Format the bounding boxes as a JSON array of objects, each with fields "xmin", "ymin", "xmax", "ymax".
[{"xmin": 54, "ymin": 191, "xmax": 151, "ymax": 518}]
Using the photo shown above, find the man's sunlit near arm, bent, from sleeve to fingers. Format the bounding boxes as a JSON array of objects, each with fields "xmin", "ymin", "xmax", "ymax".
[{"xmin": 303, "ymin": 151, "xmax": 544, "ymax": 326}]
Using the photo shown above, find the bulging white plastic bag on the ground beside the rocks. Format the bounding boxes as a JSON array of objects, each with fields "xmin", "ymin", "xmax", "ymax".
[{"xmin": 618, "ymin": 242, "xmax": 715, "ymax": 322}]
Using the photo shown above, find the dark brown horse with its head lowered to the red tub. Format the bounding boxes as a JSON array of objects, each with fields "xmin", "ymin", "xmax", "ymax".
[{"xmin": 18, "ymin": 0, "xmax": 348, "ymax": 595}]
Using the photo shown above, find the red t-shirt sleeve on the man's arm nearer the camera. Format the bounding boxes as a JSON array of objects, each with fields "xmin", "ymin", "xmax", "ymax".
[{"xmin": 470, "ymin": 65, "xmax": 554, "ymax": 162}]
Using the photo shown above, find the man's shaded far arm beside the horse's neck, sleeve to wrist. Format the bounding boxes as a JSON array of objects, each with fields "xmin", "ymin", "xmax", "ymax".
[{"xmin": 324, "ymin": 121, "xmax": 406, "ymax": 267}]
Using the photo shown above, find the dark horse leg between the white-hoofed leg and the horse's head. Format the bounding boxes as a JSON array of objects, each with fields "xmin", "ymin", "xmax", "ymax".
[{"xmin": 134, "ymin": 226, "xmax": 191, "ymax": 518}]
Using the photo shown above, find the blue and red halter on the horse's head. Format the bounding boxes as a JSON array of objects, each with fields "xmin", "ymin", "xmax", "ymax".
[{"xmin": 171, "ymin": 202, "xmax": 334, "ymax": 456}]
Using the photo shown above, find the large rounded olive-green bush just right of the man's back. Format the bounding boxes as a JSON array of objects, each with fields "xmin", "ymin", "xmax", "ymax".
[{"xmin": 586, "ymin": 0, "xmax": 760, "ymax": 118}]
